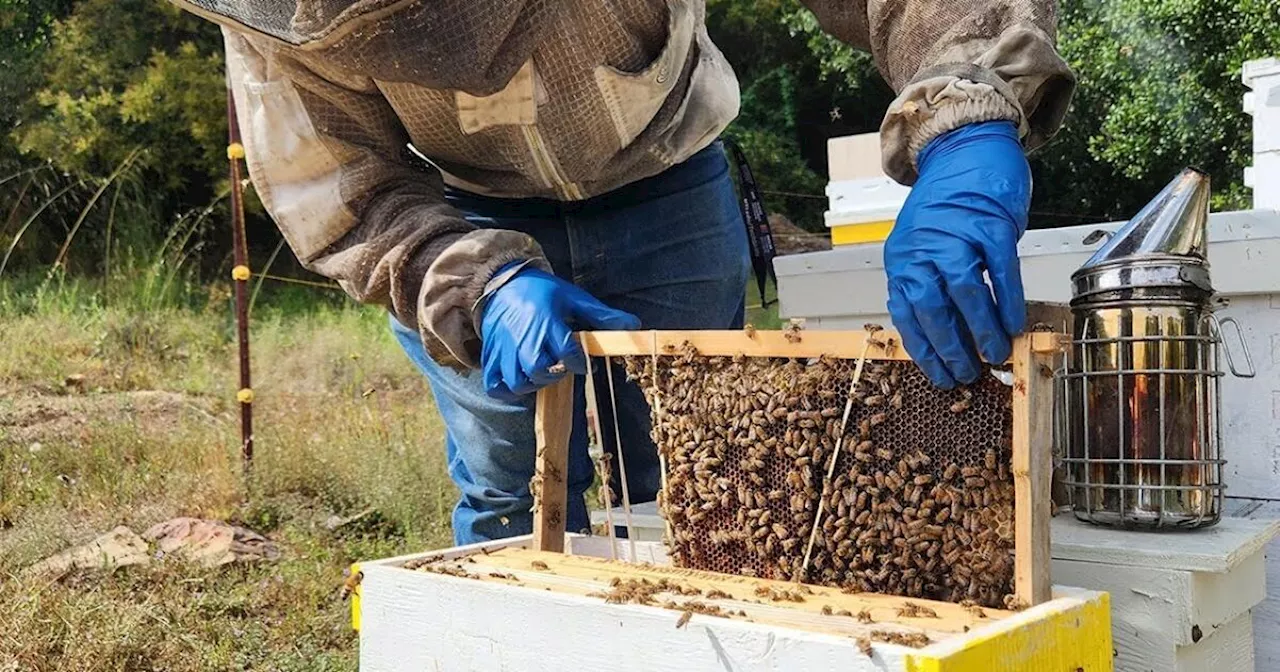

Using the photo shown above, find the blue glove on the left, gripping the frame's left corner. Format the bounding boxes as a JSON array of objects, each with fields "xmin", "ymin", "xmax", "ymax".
[{"xmin": 480, "ymin": 262, "xmax": 640, "ymax": 399}]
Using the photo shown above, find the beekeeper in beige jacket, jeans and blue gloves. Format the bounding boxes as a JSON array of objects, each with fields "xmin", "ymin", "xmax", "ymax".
[{"xmin": 170, "ymin": 0, "xmax": 1074, "ymax": 544}]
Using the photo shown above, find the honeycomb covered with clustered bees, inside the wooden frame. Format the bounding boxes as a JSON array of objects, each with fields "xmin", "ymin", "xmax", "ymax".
[{"xmin": 625, "ymin": 344, "xmax": 1015, "ymax": 608}]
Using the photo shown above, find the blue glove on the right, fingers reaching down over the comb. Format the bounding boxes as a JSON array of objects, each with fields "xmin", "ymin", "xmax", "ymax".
[{"xmin": 884, "ymin": 122, "xmax": 1032, "ymax": 388}]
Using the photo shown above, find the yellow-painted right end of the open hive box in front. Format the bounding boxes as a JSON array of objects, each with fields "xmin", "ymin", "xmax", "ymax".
[{"xmin": 906, "ymin": 589, "xmax": 1114, "ymax": 672}]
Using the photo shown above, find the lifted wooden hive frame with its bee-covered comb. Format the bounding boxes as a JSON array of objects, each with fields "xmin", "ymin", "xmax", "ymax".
[{"xmin": 535, "ymin": 330, "xmax": 1061, "ymax": 607}]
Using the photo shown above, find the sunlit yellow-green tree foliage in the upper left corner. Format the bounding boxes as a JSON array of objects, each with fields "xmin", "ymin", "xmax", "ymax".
[{"xmin": 14, "ymin": 0, "xmax": 227, "ymax": 193}]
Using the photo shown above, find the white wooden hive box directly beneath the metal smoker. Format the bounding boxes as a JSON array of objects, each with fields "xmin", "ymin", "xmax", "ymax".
[{"xmin": 591, "ymin": 502, "xmax": 1280, "ymax": 672}]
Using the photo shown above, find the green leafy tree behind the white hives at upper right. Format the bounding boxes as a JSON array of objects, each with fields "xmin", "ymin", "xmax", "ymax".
[{"xmin": 791, "ymin": 0, "xmax": 1280, "ymax": 227}]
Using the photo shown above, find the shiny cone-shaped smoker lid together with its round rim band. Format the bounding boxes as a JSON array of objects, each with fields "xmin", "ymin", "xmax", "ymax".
[{"xmin": 1071, "ymin": 168, "xmax": 1212, "ymax": 298}]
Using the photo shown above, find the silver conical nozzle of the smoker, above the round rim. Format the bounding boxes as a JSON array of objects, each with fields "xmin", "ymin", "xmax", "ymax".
[{"xmin": 1080, "ymin": 168, "xmax": 1208, "ymax": 270}]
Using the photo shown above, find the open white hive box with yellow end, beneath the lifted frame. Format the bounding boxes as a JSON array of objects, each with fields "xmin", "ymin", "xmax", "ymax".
[{"xmin": 353, "ymin": 535, "xmax": 1112, "ymax": 672}]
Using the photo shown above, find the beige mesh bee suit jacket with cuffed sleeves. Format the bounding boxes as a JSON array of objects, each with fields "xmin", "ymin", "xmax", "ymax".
[{"xmin": 167, "ymin": 0, "xmax": 1074, "ymax": 367}]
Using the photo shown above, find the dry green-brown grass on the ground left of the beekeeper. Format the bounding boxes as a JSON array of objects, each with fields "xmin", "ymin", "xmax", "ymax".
[{"xmin": 0, "ymin": 278, "xmax": 777, "ymax": 672}]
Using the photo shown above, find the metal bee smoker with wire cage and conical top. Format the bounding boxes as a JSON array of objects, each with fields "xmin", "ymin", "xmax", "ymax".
[{"xmin": 1060, "ymin": 169, "xmax": 1254, "ymax": 529}]
